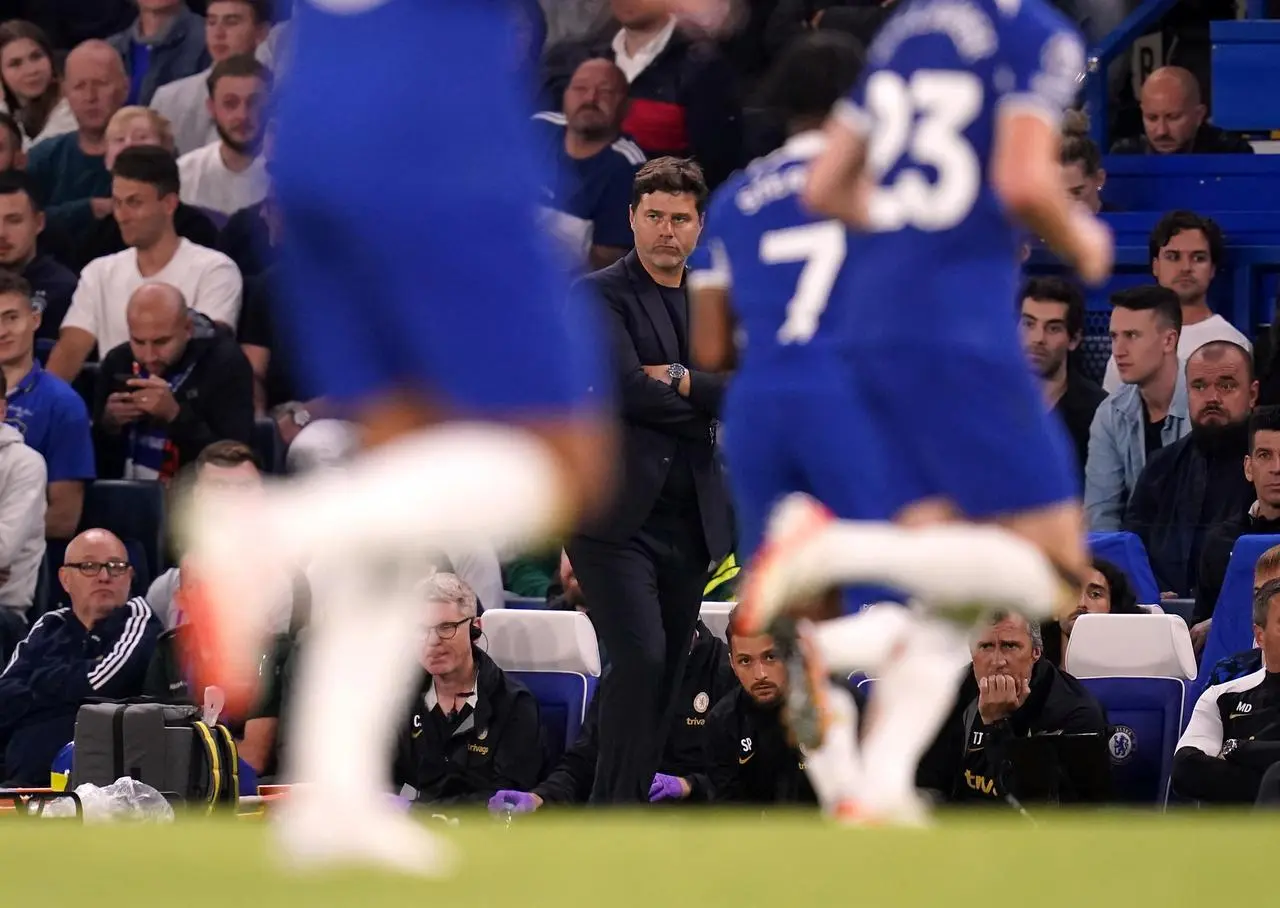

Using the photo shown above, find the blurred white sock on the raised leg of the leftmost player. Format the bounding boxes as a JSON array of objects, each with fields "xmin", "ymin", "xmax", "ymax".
[{"xmin": 261, "ymin": 423, "xmax": 572, "ymax": 561}]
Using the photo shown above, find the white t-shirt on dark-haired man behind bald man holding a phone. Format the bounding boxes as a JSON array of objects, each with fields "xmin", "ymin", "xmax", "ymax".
[{"xmin": 63, "ymin": 239, "xmax": 243, "ymax": 356}]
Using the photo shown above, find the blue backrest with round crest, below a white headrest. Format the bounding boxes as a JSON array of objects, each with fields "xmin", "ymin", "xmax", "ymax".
[{"xmin": 1071, "ymin": 671, "xmax": 1185, "ymax": 807}]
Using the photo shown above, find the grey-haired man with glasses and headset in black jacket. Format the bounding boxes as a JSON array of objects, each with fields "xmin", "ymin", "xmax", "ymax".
[{"xmin": 394, "ymin": 574, "xmax": 543, "ymax": 804}]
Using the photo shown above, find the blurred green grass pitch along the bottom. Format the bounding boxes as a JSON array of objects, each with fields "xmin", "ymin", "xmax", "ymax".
[{"xmin": 0, "ymin": 811, "xmax": 1280, "ymax": 908}]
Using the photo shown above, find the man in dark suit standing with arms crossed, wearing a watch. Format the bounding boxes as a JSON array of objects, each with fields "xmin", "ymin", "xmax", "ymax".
[{"xmin": 567, "ymin": 158, "xmax": 732, "ymax": 803}]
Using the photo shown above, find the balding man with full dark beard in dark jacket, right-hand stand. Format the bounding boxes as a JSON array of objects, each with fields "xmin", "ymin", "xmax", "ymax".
[{"xmin": 1123, "ymin": 341, "xmax": 1258, "ymax": 609}]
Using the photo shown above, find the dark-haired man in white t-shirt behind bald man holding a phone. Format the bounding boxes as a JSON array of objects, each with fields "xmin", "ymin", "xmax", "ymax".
[{"xmin": 49, "ymin": 146, "xmax": 242, "ymax": 382}]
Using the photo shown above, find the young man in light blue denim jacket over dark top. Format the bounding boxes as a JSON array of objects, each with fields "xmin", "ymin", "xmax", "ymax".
[{"xmin": 1084, "ymin": 287, "xmax": 1190, "ymax": 533}]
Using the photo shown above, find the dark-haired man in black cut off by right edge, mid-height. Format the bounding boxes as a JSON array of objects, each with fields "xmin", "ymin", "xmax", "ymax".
[{"xmin": 1192, "ymin": 407, "xmax": 1280, "ymax": 633}]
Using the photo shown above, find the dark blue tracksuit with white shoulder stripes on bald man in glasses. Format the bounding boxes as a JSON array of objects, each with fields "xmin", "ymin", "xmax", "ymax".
[{"xmin": 0, "ymin": 596, "xmax": 163, "ymax": 786}]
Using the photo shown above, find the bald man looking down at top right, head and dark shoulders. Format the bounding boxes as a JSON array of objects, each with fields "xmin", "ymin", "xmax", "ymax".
[{"xmin": 1111, "ymin": 67, "xmax": 1253, "ymax": 155}]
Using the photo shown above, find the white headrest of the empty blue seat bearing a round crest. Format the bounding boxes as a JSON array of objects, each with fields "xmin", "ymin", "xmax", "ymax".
[{"xmin": 1062, "ymin": 615, "xmax": 1196, "ymax": 680}]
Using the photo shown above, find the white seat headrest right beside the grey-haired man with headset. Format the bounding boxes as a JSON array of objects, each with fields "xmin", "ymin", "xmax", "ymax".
[{"xmin": 481, "ymin": 608, "xmax": 600, "ymax": 679}]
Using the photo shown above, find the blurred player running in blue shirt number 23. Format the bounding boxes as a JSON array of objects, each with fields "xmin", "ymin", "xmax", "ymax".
[{"xmin": 728, "ymin": 0, "xmax": 1112, "ymax": 821}]
